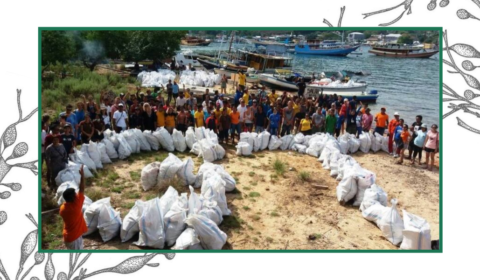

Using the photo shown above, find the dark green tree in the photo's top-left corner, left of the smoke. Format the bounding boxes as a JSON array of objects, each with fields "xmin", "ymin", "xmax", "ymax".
[{"xmin": 41, "ymin": 30, "xmax": 74, "ymax": 72}]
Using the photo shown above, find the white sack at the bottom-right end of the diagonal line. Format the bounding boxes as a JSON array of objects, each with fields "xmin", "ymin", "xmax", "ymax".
[{"xmin": 400, "ymin": 210, "xmax": 432, "ymax": 250}]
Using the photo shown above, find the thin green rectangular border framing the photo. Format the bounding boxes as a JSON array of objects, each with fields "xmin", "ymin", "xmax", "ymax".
[{"xmin": 38, "ymin": 26, "xmax": 443, "ymax": 254}]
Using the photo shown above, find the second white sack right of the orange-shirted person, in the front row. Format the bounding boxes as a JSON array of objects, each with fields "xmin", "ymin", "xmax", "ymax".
[{"xmin": 97, "ymin": 204, "xmax": 122, "ymax": 242}]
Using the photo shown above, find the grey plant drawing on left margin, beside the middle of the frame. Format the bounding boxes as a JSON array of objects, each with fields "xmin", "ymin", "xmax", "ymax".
[{"xmin": 0, "ymin": 89, "xmax": 38, "ymax": 225}]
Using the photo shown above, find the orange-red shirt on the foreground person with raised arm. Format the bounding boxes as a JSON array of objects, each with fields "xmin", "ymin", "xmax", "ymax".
[{"xmin": 60, "ymin": 192, "xmax": 87, "ymax": 242}]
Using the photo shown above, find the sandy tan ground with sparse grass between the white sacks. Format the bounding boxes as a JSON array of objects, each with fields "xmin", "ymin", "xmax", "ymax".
[{"xmin": 42, "ymin": 146, "xmax": 439, "ymax": 250}]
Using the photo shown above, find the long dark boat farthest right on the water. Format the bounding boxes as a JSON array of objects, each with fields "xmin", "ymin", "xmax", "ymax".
[{"xmin": 368, "ymin": 44, "xmax": 438, "ymax": 58}]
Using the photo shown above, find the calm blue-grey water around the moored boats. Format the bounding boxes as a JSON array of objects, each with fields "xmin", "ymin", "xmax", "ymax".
[{"xmin": 186, "ymin": 43, "xmax": 440, "ymax": 127}]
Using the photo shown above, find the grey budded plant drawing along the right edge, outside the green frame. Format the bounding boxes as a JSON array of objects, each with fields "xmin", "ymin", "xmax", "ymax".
[{"xmin": 443, "ymin": 30, "xmax": 480, "ymax": 134}]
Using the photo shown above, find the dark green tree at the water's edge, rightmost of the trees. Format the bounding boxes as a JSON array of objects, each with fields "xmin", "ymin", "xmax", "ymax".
[{"xmin": 124, "ymin": 30, "xmax": 187, "ymax": 62}]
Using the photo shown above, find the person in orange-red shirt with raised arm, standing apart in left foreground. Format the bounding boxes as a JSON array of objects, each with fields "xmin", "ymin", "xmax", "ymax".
[{"xmin": 60, "ymin": 165, "xmax": 87, "ymax": 250}]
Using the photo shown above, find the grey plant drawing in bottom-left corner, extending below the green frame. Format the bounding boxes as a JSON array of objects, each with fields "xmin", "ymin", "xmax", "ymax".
[{"xmin": 0, "ymin": 214, "xmax": 175, "ymax": 280}]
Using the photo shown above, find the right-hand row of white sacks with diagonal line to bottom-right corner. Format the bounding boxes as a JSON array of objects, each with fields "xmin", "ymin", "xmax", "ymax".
[{"xmin": 237, "ymin": 131, "xmax": 431, "ymax": 250}]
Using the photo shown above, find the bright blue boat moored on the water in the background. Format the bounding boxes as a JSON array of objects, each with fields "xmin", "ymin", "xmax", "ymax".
[{"xmin": 295, "ymin": 41, "xmax": 360, "ymax": 56}]
